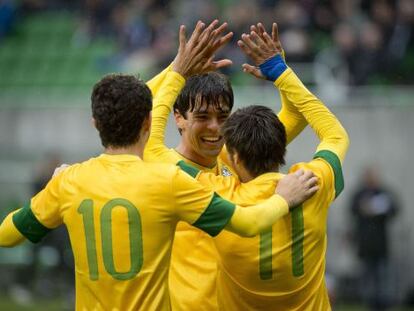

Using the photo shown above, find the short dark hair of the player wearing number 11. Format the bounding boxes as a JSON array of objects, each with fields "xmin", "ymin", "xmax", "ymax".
[{"xmin": 222, "ymin": 105, "xmax": 286, "ymax": 177}]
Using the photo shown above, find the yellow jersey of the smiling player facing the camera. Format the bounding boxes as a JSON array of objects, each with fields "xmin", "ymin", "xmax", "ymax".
[{"xmin": 144, "ymin": 71, "xmax": 233, "ymax": 311}]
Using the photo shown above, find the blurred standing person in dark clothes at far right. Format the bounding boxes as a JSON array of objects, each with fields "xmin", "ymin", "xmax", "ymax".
[{"xmin": 351, "ymin": 167, "xmax": 398, "ymax": 311}]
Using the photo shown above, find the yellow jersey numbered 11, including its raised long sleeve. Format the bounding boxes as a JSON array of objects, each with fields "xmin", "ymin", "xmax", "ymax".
[{"xmin": 192, "ymin": 68, "xmax": 349, "ymax": 311}]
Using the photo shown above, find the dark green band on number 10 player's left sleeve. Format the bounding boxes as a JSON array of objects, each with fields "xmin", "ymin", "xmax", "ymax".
[{"xmin": 13, "ymin": 202, "xmax": 51, "ymax": 243}]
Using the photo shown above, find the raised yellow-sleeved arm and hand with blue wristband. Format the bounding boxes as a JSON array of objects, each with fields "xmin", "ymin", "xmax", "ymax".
[{"xmin": 238, "ymin": 24, "xmax": 349, "ymax": 162}]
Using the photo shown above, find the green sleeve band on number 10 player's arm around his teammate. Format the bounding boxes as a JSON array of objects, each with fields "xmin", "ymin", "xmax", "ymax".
[{"xmin": 193, "ymin": 193, "xmax": 236, "ymax": 236}]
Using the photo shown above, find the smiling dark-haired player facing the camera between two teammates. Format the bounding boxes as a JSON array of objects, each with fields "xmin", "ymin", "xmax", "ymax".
[{"xmin": 144, "ymin": 27, "xmax": 306, "ymax": 311}]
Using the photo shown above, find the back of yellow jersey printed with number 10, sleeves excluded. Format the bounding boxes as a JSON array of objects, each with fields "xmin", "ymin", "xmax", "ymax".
[{"xmin": 52, "ymin": 155, "xmax": 186, "ymax": 310}]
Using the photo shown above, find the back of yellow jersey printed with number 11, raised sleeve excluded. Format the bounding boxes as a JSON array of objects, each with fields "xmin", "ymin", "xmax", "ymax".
[{"xmin": 212, "ymin": 160, "xmax": 333, "ymax": 310}]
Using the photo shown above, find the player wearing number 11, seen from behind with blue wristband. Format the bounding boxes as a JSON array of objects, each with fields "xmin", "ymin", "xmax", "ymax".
[{"xmin": 146, "ymin": 24, "xmax": 349, "ymax": 310}]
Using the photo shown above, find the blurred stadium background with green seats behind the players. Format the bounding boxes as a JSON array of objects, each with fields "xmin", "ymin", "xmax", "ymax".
[{"xmin": 0, "ymin": 0, "xmax": 414, "ymax": 310}]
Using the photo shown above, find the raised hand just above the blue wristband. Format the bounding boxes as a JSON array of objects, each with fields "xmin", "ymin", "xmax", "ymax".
[{"xmin": 237, "ymin": 23, "xmax": 283, "ymax": 79}]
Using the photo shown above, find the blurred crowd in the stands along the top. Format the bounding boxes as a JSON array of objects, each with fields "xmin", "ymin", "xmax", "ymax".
[{"xmin": 0, "ymin": 0, "xmax": 414, "ymax": 86}]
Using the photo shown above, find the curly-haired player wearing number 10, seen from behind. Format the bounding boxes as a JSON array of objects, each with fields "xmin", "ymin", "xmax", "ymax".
[{"xmin": 0, "ymin": 20, "xmax": 313, "ymax": 310}]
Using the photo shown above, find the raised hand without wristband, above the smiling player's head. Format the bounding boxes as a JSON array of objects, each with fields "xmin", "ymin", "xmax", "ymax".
[{"xmin": 173, "ymin": 20, "xmax": 233, "ymax": 78}]
